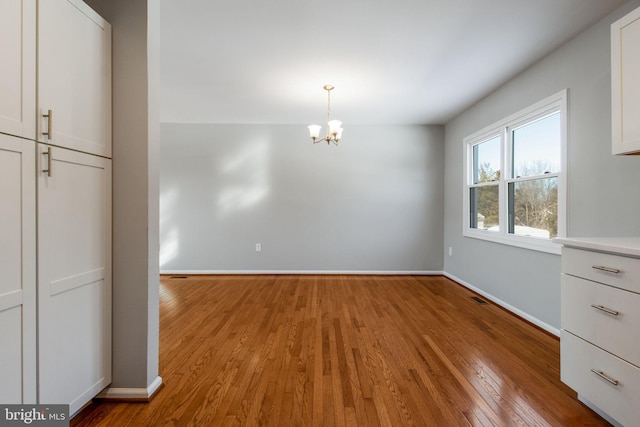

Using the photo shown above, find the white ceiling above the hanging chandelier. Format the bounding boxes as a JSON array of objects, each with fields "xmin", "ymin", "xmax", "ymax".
[{"xmin": 160, "ymin": 0, "xmax": 625, "ymax": 128}]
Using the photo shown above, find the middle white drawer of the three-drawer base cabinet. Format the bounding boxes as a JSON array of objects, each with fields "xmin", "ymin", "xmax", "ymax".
[{"xmin": 561, "ymin": 274, "xmax": 640, "ymax": 366}]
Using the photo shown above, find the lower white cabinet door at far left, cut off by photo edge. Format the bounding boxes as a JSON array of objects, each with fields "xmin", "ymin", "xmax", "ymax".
[{"xmin": 0, "ymin": 134, "xmax": 36, "ymax": 404}]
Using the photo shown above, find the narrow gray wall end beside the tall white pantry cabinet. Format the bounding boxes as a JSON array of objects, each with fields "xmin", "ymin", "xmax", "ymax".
[{"xmin": 85, "ymin": 0, "xmax": 160, "ymax": 390}]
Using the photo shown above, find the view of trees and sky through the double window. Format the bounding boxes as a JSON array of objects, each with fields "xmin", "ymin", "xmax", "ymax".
[{"xmin": 468, "ymin": 111, "xmax": 561, "ymax": 239}]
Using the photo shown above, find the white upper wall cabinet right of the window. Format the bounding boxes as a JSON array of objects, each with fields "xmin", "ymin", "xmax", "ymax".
[{"xmin": 611, "ymin": 8, "xmax": 640, "ymax": 154}]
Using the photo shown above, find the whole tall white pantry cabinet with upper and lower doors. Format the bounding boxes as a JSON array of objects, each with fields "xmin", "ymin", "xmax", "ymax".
[{"xmin": 0, "ymin": 0, "xmax": 111, "ymax": 414}]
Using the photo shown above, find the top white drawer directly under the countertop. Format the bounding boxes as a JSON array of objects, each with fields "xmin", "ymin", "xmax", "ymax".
[{"xmin": 562, "ymin": 246, "xmax": 640, "ymax": 293}]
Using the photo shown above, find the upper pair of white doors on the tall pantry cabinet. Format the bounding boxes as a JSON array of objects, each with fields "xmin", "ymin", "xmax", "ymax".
[{"xmin": 0, "ymin": 0, "xmax": 111, "ymax": 157}]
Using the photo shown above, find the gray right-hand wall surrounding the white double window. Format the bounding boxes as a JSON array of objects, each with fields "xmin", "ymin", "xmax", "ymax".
[{"xmin": 444, "ymin": 0, "xmax": 640, "ymax": 328}]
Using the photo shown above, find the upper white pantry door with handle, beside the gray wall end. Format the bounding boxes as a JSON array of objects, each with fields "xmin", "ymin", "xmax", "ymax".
[{"xmin": 38, "ymin": 0, "xmax": 111, "ymax": 157}]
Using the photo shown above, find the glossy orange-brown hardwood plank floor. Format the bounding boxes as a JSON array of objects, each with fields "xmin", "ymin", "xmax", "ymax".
[{"xmin": 74, "ymin": 275, "xmax": 608, "ymax": 427}]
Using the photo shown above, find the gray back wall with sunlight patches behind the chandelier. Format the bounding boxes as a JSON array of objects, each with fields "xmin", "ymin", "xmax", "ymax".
[{"xmin": 160, "ymin": 123, "xmax": 444, "ymax": 272}]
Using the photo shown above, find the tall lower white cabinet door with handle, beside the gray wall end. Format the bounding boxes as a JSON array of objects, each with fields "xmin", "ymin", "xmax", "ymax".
[{"xmin": 38, "ymin": 144, "xmax": 111, "ymax": 414}]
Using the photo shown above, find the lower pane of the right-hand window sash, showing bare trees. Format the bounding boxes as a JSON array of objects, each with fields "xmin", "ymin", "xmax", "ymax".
[{"xmin": 509, "ymin": 177, "xmax": 558, "ymax": 239}]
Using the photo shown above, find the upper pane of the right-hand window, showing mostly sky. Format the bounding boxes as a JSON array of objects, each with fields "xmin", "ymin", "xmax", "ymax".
[{"xmin": 511, "ymin": 112, "xmax": 561, "ymax": 178}]
